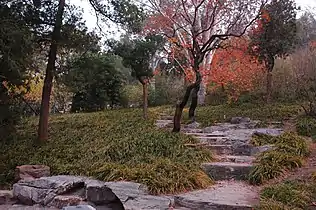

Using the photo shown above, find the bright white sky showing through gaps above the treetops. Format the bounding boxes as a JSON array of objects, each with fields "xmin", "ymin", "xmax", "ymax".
[{"xmin": 68, "ymin": 0, "xmax": 316, "ymax": 38}]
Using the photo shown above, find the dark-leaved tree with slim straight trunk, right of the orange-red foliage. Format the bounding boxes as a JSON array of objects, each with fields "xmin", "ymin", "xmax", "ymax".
[{"xmin": 251, "ymin": 0, "xmax": 296, "ymax": 102}]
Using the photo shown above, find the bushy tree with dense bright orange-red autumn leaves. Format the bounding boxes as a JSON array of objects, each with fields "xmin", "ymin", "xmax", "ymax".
[{"xmin": 208, "ymin": 37, "xmax": 264, "ymax": 102}]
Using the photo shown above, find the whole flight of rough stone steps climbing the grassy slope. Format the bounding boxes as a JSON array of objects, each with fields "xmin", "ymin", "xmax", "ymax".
[{"xmin": 156, "ymin": 115, "xmax": 282, "ymax": 210}]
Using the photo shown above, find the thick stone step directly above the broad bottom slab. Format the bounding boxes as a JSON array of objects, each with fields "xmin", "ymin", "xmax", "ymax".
[{"xmin": 202, "ymin": 162, "xmax": 253, "ymax": 181}]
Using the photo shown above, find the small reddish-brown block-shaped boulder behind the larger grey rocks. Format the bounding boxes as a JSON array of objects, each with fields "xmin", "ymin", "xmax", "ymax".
[{"xmin": 15, "ymin": 165, "xmax": 50, "ymax": 181}]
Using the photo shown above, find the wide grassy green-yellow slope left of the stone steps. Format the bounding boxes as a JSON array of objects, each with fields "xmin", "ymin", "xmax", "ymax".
[{"xmin": 0, "ymin": 108, "xmax": 211, "ymax": 193}]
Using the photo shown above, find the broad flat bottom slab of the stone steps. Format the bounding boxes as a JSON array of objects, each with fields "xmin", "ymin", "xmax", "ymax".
[{"xmin": 175, "ymin": 181, "xmax": 259, "ymax": 210}]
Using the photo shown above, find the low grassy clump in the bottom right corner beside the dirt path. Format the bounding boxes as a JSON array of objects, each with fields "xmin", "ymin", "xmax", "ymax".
[{"xmin": 259, "ymin": 180, "xmax": 316, "ymax": 210}]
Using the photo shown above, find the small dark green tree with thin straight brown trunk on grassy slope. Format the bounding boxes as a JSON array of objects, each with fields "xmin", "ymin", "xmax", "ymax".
[{"xmin": 109, "ymin": 35, "xmax": 163, "ymax": 119}]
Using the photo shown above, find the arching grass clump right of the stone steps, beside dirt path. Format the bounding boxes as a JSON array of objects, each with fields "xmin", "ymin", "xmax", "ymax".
[{"xmin": 249, "ymin": 133, "xmax": 310, "ymax": 184}]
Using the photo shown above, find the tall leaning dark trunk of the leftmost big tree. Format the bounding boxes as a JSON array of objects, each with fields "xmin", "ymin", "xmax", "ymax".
[{"xmin": 38, "ymin": 0, "xmax": 65, "ymax": 142}]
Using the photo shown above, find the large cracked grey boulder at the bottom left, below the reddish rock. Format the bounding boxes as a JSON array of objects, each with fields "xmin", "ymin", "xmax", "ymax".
[{"xmin": 13, "ymin": 176, "xmax": 124, "ymax": 210}]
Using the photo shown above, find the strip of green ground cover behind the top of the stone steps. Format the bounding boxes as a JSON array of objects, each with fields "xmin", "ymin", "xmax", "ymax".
[{"xmin": 196, "ymin": 103, "xmax": 300, "ymax": 126}]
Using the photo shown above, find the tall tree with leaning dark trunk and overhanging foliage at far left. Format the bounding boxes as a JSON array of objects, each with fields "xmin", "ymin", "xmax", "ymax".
[{"xmin": 3, "ymin": 0, "xmax": 142, "ymax": 141}]
